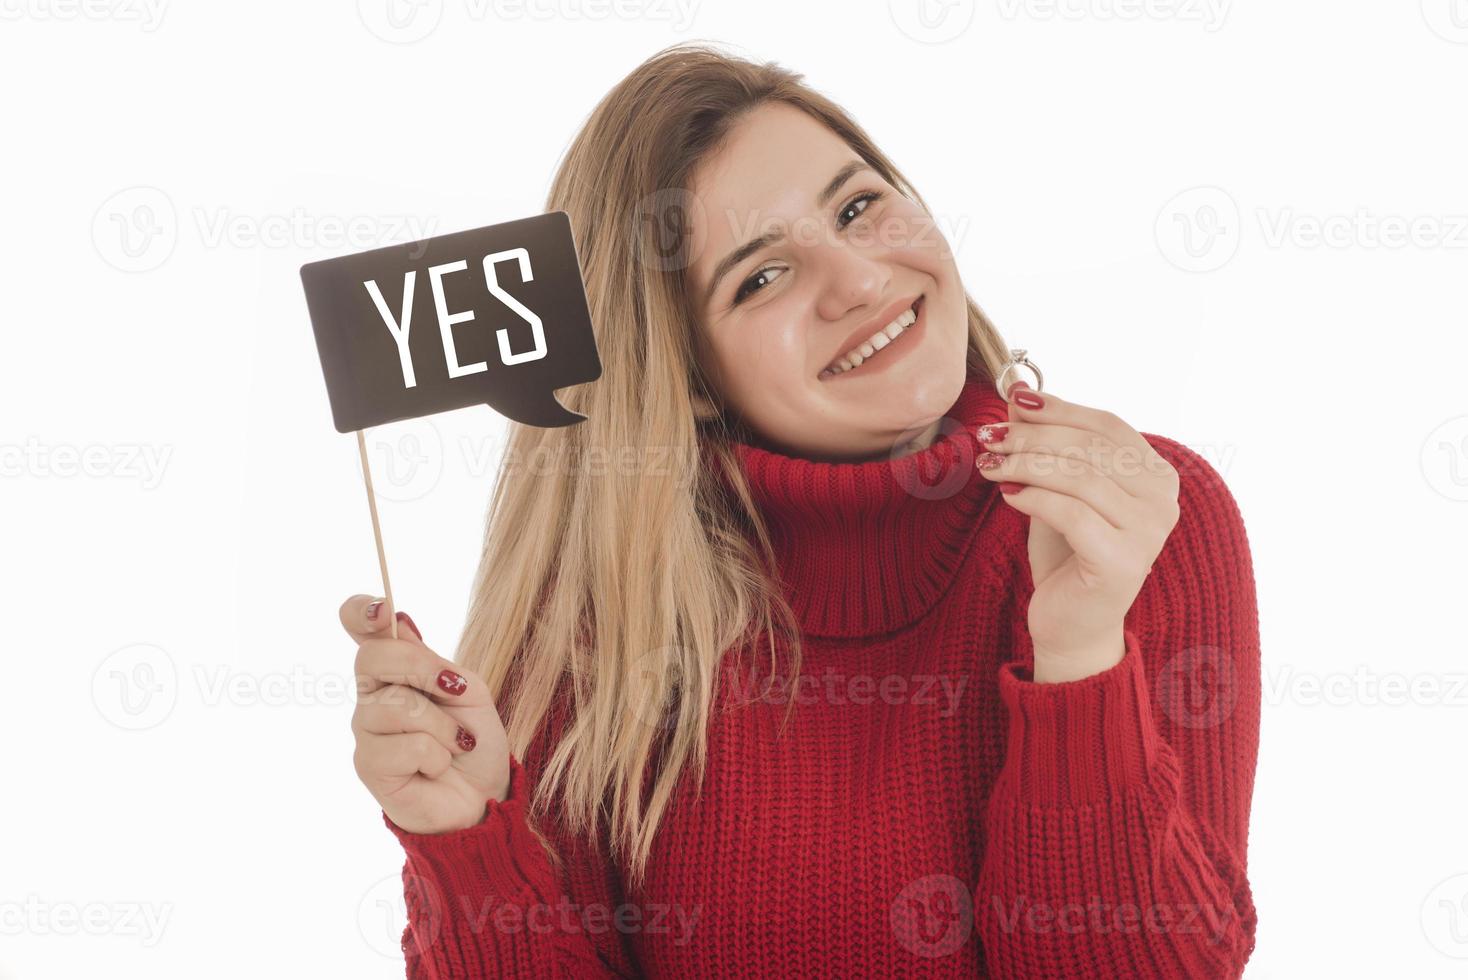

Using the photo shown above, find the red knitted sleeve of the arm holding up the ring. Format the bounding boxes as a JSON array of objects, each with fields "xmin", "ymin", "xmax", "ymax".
[{"xmin": 975, "ymin": 436, "xmax": 1260, "ymax": 980}]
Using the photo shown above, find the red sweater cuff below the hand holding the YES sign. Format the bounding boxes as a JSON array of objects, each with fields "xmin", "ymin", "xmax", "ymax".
[{"xmin": 382, "ymin": 756, "xmax": 549, "ymax": 915}]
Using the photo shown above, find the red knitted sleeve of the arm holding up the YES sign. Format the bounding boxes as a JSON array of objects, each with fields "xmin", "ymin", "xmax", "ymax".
[{"xmin": 383, "ymin": 757, "xmax": 634, "ymax": 980}]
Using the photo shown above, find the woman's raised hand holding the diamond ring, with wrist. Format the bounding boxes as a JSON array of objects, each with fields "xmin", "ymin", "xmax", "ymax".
[{"xmin": 976, "ymin": 381, "xmax": 1179, "ymax": 682}]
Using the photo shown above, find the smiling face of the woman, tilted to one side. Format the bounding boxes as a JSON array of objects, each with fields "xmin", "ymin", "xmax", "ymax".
[{"xmin": 687, "ymin": 103, "xmax": 967, "ymax": 461}]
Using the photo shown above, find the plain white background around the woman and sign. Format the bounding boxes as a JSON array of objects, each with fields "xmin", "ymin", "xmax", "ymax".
[{"xmin": 0, "ymin": 0, "xmax": 1468, "ymax": 980}]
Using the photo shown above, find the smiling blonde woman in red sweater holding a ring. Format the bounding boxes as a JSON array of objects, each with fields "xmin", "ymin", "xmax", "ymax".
[{"xmin": 341, "ymin": 45, "xmax": 1260, "ymax": 980}]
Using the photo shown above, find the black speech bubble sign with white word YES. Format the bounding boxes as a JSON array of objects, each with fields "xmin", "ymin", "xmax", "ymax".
[{"xmin": 301, "ymin": 211, "xmax": 602, "ymax": 433}]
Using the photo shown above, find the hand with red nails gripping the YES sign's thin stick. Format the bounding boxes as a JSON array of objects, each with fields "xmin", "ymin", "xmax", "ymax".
[{"xmin": 341, "ymin": 596, "xmax": 509, "ymax": 833}]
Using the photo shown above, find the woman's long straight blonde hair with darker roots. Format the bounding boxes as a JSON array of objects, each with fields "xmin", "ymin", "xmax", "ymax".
[{"xmin": 458, "ymin": 44, "xmax": 1006, "ymax": 880}]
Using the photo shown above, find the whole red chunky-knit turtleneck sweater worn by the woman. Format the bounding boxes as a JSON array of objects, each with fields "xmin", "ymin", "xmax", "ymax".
[{"xmin": 383, "ymin": 376, "xmax": 1260, "ymax": 980}]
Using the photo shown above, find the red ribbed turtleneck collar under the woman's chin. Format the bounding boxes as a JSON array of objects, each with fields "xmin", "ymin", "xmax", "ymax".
[{"xmin": 734, "ymin": 368, "xmax": 1009, "ymax": 638}]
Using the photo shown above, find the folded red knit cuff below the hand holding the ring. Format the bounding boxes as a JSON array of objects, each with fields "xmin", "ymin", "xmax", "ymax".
[{"xmin": 1000, "ymin": 629, "xmax": 1158, "ymax": 807}]
